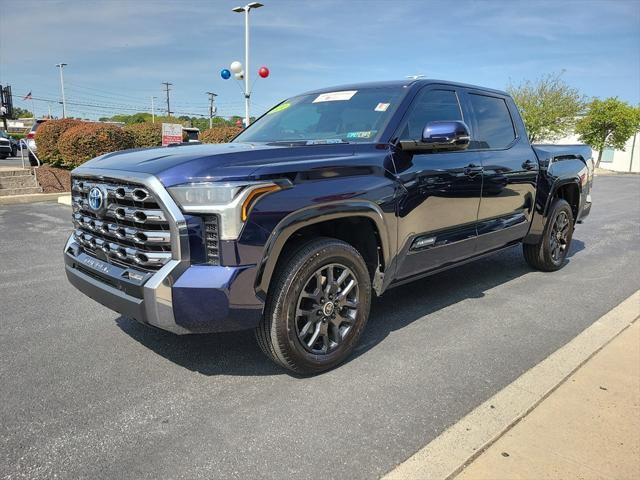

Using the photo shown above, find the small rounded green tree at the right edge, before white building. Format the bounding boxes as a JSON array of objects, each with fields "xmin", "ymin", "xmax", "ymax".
[{"xmin": 576, "ymin": 97, "xmax": 640, "ymax": 167}]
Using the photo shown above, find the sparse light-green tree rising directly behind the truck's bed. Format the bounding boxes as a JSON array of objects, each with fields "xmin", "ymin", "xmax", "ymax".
[{"xmin": 507, "ymin": 73, "xmax": 586, "ymax": 143}]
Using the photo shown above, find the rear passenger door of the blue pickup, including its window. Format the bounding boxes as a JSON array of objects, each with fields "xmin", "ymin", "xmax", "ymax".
[{"xmin": 462, "ymin": 90, "xmax": 538, "ymax": 253}]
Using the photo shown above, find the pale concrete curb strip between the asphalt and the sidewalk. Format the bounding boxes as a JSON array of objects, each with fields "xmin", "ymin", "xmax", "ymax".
[{"xmin": 383, "ymin": 290, "xmax": 640, "ymax": 480}]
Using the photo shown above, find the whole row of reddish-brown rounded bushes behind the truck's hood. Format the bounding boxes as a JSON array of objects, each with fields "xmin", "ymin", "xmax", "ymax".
[{"xmin": 36, "ymin": 118, "xmax": 242, "ymax": 167}]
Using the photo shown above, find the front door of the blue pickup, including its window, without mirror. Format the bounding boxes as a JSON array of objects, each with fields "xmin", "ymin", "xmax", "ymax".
[{"xmin": 394, "ymin": 86, "xmax": 482, "ymax": 280}]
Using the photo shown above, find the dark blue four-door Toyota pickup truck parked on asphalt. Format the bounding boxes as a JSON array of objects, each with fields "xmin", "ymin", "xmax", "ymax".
[{"xmin": 64, "ymin": 80, "xmax": 593, "ymax": 374}]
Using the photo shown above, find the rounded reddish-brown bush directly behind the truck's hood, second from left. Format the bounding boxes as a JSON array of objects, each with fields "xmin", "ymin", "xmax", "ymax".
[{"xmin": 57, "ymin": 123, "xmax": 135, "ymax": 166}]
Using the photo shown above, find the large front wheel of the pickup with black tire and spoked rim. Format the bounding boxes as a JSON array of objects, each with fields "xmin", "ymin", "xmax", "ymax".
[{"xmin": 255, "ymin": 238, "xmax": 371, "ymax": 375}]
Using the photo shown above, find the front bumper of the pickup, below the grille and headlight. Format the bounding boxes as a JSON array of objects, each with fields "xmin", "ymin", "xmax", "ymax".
[{"xmin": 64, "ymin": 235, "xmax": 263, "ymax": 335}]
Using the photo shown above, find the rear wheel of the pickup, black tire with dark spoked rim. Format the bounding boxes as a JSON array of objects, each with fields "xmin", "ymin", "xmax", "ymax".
[{"xmin": 522, "ymin": 198, "xmax": 575, "ymax": 272}]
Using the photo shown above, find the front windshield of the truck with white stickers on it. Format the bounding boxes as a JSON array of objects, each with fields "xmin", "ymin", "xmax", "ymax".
[{"xmin": 233, "ymin": 87, "xmax": 404, "ymax": 145}]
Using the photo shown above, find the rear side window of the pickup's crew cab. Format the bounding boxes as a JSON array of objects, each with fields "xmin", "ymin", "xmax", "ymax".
[{"xmin": 469, "ymin": 93, "xmax": 516, "ymax": 150}]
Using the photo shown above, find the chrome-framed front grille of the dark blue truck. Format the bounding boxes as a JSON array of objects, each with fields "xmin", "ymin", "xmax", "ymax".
[{"xmin": 71, "ymin": 178, "xmax": 171, "ymax": 271}]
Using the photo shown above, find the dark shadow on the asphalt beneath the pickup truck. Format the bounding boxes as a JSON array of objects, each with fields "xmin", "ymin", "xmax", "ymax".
[{"xmin": 116, "ymin": 238, "xmax": 584, "ymax": 377}]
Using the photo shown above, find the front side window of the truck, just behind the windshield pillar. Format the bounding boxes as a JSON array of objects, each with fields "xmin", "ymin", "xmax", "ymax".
[{"xmin": 400, "ymin": 90, "xmax": 462, "ymax": 140}]
